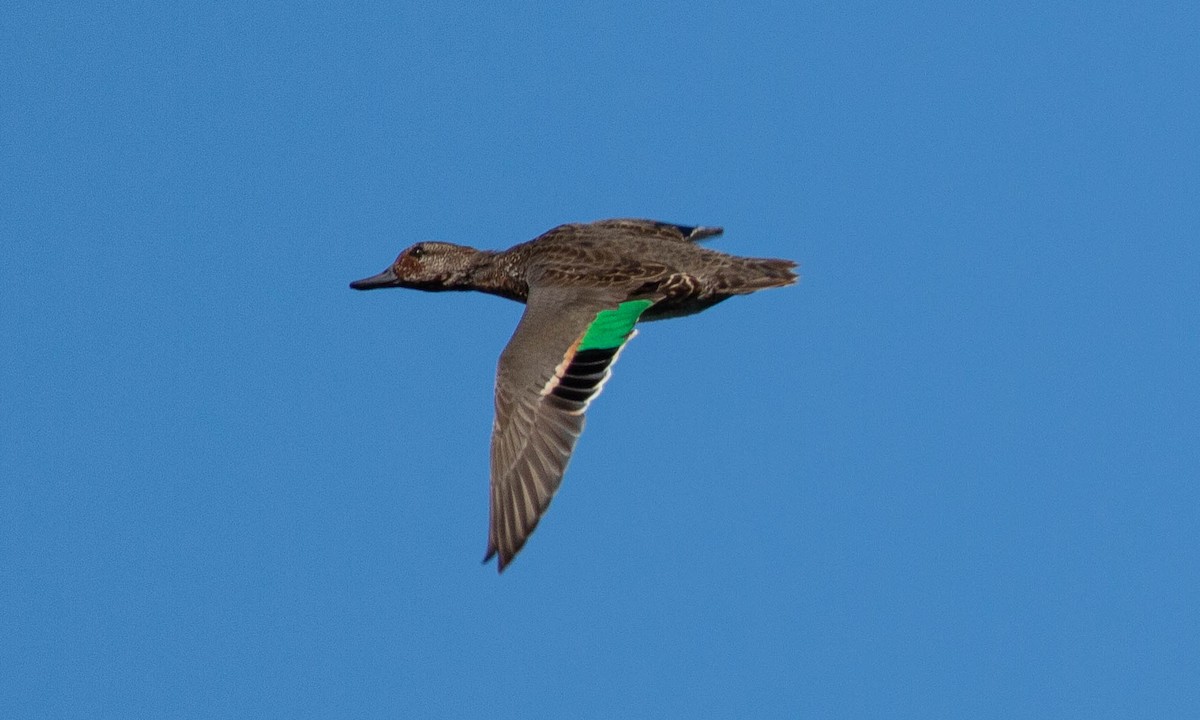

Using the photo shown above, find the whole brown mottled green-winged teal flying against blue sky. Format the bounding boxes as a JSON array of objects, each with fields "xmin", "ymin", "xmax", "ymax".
[{"xmin": 350, "ymin": 220, "xmax": 796, "ymax": 571}]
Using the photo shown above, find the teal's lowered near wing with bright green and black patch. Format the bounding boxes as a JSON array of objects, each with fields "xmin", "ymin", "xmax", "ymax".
[{"xmin": 484, "ymin": 288, "xmax": 653, "ymax": 571}]
